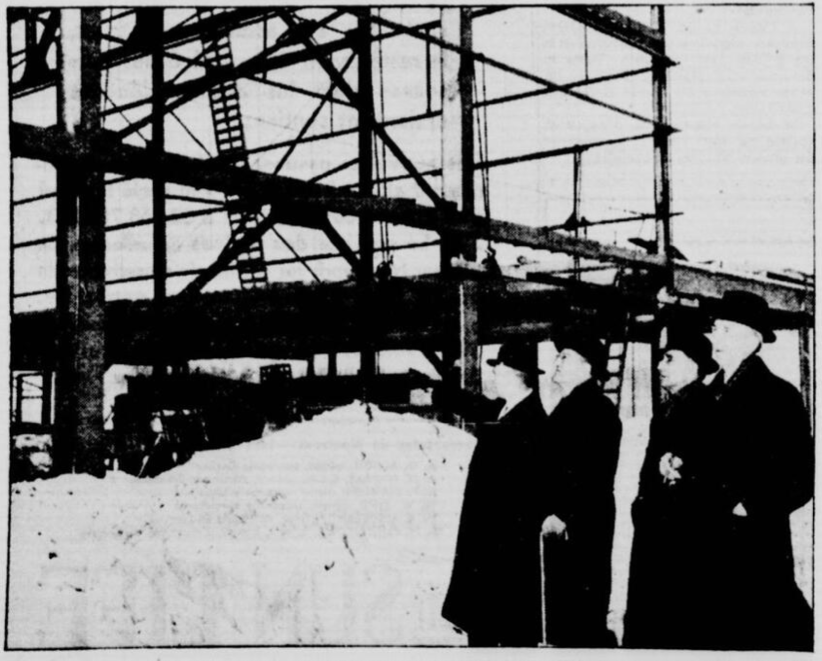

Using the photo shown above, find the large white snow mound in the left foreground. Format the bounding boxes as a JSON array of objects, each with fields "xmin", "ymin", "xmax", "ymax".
[{"xmin": 8, "ymin": 404, "xmax": 474, "ymax": 648}]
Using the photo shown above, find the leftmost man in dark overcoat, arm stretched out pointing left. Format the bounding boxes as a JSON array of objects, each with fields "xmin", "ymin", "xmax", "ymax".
[{"xmin": 442, "ymin": 340, "xmax": 547, "ymax": 647}]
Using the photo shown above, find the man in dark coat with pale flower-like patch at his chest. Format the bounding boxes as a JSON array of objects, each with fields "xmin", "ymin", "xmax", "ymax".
[{"xmin": 623, "ymin": 326, "xmax": 724, "ymax": 649}]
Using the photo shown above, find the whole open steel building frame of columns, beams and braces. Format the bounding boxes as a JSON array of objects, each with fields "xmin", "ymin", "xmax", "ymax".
[{"xmin": 7, "ymin": 5, "xmax": 813, "ymax": 472}]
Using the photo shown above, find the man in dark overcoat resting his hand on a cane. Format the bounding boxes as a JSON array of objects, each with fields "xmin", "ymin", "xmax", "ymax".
[{"xmin": 541, "ymin": 330, "xmax": 622, "ymax": 647}]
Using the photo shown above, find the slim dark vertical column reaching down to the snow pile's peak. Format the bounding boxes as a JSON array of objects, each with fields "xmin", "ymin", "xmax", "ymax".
[{"xmin": 357, "ymin": 8, "xmax": 377, "ymax": 400}]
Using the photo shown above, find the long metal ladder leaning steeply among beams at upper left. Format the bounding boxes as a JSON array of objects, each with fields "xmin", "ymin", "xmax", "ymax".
[{"xmin": 197, "ymin": 8, "xmax": 268, "ymax": 289}]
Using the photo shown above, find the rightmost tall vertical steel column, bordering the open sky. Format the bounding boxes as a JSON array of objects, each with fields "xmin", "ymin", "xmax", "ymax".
[{"xmin": 651, "ymin": 5, "xmax": 673, "ymax": 257}]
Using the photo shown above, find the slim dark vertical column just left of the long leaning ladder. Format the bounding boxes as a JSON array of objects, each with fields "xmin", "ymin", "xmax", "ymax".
[{"xmin": 150, "ymin": 7, "xmax": 168, "ymax": 378}]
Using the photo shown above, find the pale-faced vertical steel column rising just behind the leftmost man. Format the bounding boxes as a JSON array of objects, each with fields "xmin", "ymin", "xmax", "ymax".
[{"xmin": 440, "ymin": 7, "xmax": 482, "ymax": 392}]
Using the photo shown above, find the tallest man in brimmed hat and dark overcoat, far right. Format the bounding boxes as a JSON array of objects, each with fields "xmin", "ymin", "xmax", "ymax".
[{"xmin": 708, "ymin": 291, "xmax": 814, "ymax": 650}]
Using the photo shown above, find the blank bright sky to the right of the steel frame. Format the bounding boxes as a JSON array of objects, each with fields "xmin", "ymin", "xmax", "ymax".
[{"xmin": 667, "ymin": 5, "xmax": 814, "ymax": 272}]
